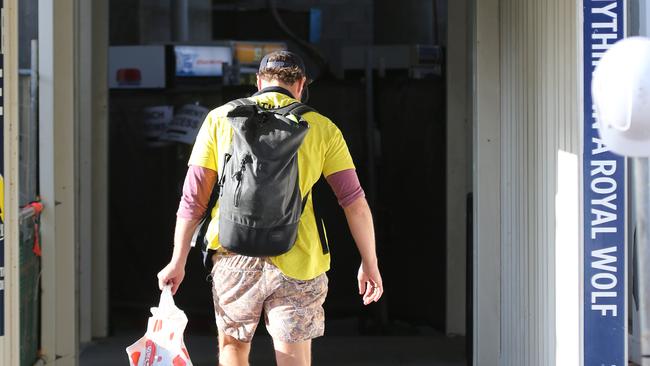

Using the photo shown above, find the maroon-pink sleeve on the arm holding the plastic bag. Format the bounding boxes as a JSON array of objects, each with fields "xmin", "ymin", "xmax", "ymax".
[{"xmin": 176, "ymin": 165, "xmax": 217, "ymax": 220}]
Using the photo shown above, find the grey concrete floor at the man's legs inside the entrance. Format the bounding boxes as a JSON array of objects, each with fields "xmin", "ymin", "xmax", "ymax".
[{"xmin": 80, "ymin": 334, "xmax": 466, "ymax": 366}]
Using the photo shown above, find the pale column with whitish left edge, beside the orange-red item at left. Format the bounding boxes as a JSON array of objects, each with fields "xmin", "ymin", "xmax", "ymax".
[{"xmin": 38, "ymin": 0, "xmax": 79, "ymax": 365}]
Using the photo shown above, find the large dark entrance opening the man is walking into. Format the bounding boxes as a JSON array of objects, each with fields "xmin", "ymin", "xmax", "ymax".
[{"xmin": 108, "ymin": 0, "xmax": 471, "ymax": 365}]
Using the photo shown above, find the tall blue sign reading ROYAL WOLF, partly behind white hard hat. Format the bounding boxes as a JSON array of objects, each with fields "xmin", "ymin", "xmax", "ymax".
[{"xmin": 583, "ymin": 0, "xmax": 627, "ymax": 366}]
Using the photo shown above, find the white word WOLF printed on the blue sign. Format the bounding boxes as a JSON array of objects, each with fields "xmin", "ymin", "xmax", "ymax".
[{"xmin": 591, "ymin": 246, "xmax": 618, "ymax": 316}]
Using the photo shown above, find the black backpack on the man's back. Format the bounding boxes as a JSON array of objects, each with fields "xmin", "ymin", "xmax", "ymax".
[{"xmin": 193, "ymin": 98, "xmax": 314, "ymax": 268}]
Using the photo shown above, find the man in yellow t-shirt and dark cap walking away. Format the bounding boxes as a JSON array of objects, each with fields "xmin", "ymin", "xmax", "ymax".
[{"xmin": 158, "ymin": 51, "xmax": 383, "ymax": 366}]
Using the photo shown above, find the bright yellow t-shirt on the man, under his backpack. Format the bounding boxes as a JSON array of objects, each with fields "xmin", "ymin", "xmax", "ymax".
[{"xmin": 189, "ymin": 91, "xmax": 354, "ymax": 280}]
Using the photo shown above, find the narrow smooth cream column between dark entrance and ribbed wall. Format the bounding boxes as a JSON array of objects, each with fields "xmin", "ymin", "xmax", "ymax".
[{"xmin": 473, "ymin": 0, "xmax": 501, "ymax": 366}]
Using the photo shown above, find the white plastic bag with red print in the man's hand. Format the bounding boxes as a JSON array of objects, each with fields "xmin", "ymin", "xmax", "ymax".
[{"xmin": 126, "ymin": 286, "xmax": 192, "ymax": 366}]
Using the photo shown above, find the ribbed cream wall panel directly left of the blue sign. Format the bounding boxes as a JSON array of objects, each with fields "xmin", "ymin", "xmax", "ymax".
[{"xmin": 499, "ymin": 0, "xmax": 579, "ymax": 365}]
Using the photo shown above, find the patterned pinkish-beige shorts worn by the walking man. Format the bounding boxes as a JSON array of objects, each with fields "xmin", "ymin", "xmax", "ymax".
[{"xmin": 212, "ymin": 253, "xmax": 328, "ymax": 343}]
